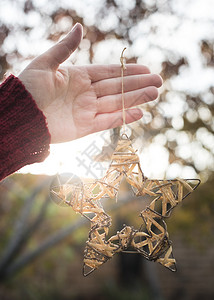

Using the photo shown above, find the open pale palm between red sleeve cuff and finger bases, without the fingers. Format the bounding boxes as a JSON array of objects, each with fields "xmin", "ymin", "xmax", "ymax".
[{"xmin": 19, "ymin": 64, "xmax": 97, "ymax": 143}]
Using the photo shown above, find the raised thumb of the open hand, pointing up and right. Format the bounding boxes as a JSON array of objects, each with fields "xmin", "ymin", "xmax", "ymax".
[{"xmin": 40, "ymin": 23, "xmax": 83, "ymax": 69}]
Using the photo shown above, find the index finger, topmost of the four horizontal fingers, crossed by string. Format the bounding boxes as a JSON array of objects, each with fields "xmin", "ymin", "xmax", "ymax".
[{"xmin": 87, "ymin": 64, "xmax": 150, "ymax": 83}]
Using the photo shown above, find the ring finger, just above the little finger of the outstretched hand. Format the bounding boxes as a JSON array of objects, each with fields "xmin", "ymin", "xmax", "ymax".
[{"xmin": 97, "ymin": 86, "xmax": 158, "ymax": 113}]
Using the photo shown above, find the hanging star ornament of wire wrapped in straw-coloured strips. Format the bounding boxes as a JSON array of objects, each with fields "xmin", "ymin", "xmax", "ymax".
[{"xmin": 53, "ymin": 134, "xmax": 200, "ymax": 276}]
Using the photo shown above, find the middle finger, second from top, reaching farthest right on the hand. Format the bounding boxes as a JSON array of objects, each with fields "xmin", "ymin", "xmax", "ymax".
[{"xmin": 92, "ymin": 74, "xmax": 162, "ymax": 97}]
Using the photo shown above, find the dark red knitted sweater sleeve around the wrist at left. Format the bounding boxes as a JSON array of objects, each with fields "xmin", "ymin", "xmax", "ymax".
[{"xmin": 0, "ymin": 75, "xmax": 50, "ymax": 180}]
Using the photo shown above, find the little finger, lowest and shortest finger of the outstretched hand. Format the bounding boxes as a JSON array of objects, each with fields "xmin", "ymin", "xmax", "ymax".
[{"xmin": 94, "ymin": 108, "xmax": 143, "ymax": 132}]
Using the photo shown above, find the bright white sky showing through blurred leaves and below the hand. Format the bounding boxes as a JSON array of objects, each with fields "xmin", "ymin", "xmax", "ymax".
[{"xmin": 0, "ymin": 0, "xmax": 214, "ymax": 179}]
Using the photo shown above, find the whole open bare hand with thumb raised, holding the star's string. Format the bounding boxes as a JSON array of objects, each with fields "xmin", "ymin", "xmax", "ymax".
[{"xmin": 19, "ymin": 24, "xmax": 162, "ymax": 143}]
